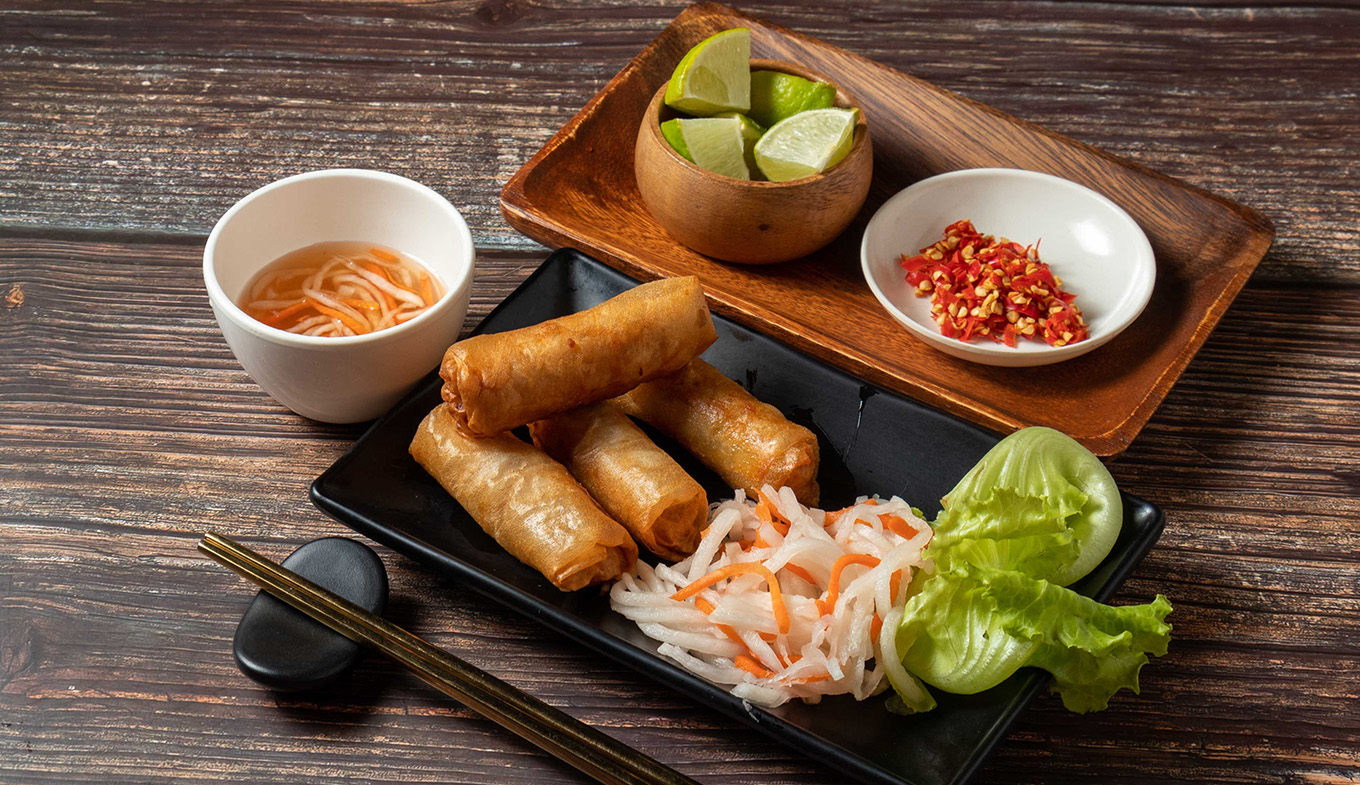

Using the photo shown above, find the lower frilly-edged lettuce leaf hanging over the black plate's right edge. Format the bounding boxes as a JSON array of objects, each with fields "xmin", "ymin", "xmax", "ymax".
[{"xmin": 896, "ymin": 559, "xmax": 1171, "ymax": 713}]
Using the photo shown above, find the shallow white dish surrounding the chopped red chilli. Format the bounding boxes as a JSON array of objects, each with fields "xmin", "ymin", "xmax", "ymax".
[{"xmin": 860, "ymin": 169, "xmax": 1157, "ymax": 367}]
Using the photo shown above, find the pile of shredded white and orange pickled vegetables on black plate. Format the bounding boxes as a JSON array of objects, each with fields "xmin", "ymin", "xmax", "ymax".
[{"xmin": 609, "ymin": 486, "xmax": 930, "ymax": 706}]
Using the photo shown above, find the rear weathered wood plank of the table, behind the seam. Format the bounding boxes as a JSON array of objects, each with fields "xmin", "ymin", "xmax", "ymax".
[{"xmin": 0, "ymin": 0, "xmax": 1360, "ymax": 282}]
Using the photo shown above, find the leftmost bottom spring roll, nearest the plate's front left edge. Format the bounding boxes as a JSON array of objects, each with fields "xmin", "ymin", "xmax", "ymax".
[{"xmin": 411, "ymin": 405, "xmax": 638, "ymax": 592}]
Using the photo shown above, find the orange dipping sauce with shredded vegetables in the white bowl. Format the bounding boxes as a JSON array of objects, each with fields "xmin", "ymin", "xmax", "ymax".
[{"xmin": 239, "ymin": 241, "xmax": 443, "ymax": 337}]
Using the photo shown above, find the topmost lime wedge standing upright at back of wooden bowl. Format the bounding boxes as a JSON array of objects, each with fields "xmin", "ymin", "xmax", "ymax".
[{"xmin": 666, "ymin": 27, "xmax": 751, "ymax": 117}]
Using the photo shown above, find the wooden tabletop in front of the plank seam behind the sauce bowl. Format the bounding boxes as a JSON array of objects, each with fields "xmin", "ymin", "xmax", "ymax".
[{"xmin": 0, "ymin": 237, "xmax": 1360, "ymax": 784}]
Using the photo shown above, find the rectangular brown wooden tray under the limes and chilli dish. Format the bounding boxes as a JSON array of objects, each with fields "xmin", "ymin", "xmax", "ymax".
[{"xmin": 500, "ymin": 3, "xmax": 1274, "ymax": 456}]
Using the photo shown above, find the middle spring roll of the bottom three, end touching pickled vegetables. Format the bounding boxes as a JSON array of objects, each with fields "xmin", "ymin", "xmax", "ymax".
[{"xmin": 529, "ymin": 401, "xmax": 709, "ymax": 561}]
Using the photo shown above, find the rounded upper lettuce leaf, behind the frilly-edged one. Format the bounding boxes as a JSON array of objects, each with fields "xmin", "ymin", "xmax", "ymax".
[{"xmin": 930, "ymin": 427, "xmax": 1123, "ymax": 586}]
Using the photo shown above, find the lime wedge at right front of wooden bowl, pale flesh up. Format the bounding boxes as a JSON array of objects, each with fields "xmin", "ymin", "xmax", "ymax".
[{"xmin": 756, "ymin": 109, "xmax": 860, "ymax": 182}]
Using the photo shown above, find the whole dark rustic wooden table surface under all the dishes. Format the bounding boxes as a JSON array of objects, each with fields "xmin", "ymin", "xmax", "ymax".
[{"xmin": 0, "ymin": 0, "xmax": 1360, "ymax": 784}]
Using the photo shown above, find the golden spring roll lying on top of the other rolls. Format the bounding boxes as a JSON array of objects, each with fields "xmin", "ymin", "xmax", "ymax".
[{"xmin": 439, "ymin": 276, "xmax": 718, "ymax": 437}]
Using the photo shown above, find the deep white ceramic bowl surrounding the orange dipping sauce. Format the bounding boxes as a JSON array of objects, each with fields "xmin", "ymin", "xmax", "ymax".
[{"xmin": 203, "ymin": 169, "xmax": 473, "ymax": 423}]
